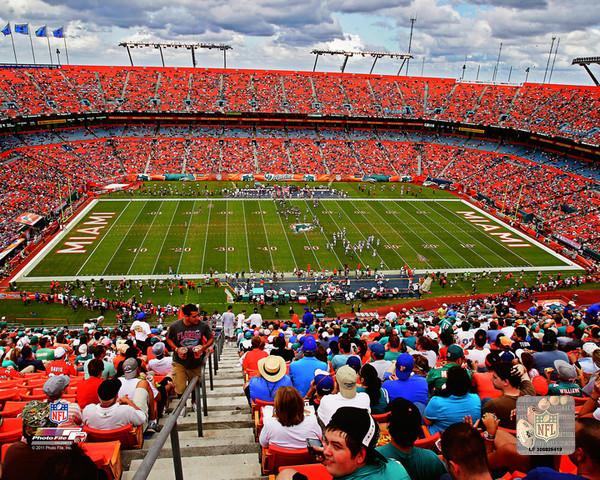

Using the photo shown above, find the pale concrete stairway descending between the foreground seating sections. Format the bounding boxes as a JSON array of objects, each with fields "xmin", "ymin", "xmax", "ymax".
[{"xmin": 122, "ymin": 345, "xmax": 261, "ymax": 480}]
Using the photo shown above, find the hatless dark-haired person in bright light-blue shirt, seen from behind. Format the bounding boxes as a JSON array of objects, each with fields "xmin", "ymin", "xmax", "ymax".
[{"xmin": 425, "ymin": 366, "xmax": 481, "ymax": 435}]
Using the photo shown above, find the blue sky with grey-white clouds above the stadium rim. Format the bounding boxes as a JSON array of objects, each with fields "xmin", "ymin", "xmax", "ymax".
[{"xmin": 0, "ymin": 0, "xmax": 600, "ymax": 85}]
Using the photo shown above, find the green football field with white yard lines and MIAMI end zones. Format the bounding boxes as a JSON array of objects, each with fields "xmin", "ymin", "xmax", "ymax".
[{"xmin": 18, "ymin": 198, "xmax": 577, "ymax": 281}]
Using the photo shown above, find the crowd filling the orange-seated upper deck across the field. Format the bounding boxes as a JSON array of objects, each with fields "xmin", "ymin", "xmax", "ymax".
[{"xmin": 0, "ymin": 66, "xmax": 600, "ymax": 144}]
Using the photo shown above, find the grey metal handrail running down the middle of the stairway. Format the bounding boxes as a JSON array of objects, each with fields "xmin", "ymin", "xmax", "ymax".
[{"xmin": 133, "ymin": 357, "xmax": 208, "ymax": 480}]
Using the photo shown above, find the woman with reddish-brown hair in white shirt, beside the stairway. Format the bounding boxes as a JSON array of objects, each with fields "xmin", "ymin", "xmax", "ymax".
[{"xmin": 259, "ymin": 387, "xmax": 322, "ymax": 448}]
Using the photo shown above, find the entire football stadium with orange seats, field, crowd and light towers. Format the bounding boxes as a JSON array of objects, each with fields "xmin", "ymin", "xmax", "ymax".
[{"xmin": 0, "ymin": 5, "xmax": 600, "ymax": 480}]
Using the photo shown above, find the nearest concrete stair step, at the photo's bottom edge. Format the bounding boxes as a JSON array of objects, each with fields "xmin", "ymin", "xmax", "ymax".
[{"xmin": 122, "ymin": 453, "xmax": 261, "ymax": 480}]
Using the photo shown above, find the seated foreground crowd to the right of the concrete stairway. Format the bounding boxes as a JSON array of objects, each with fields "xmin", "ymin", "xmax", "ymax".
[{"xmin": 236, "ymin": 295, "xmax": 600, "ymax": 480}]
